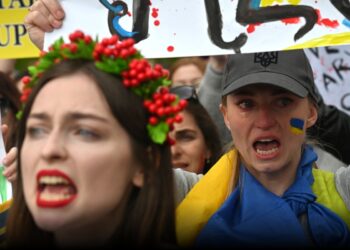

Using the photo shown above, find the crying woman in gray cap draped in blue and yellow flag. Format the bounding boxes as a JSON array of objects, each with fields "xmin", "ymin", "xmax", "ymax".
[{"xmin": 176, "ymin": 50, "xmax": 350, "ymax": 247}]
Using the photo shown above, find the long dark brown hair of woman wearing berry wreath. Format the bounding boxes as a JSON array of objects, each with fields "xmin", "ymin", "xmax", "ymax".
[{"xmin": 7, "ymin": 60, "xmax": 175, "ymax": 246}]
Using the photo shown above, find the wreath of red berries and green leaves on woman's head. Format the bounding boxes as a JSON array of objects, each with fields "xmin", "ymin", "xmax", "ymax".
[{"xmin": 17, "ymin": 30, "xmax": 187, "ymax": 144}]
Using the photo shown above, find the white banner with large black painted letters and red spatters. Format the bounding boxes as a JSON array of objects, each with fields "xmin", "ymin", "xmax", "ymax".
[{"xmin": 45, "ymin": 0, "xmax": 350, "ymax": 58}]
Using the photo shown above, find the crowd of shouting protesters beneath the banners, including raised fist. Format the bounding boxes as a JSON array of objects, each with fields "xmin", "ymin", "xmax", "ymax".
[{"xmin": 0, "ymin": 0, "xmax": 350, "ymax": 248}]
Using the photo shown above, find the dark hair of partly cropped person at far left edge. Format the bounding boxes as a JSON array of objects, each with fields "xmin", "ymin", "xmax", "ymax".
[{"xmin": 0, "ymin": 72, "xmax": 21, "ymax": 150}]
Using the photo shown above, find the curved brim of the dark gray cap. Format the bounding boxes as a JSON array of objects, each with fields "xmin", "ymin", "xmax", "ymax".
[{"xmin": 221, "ymin": 72, "xmax": 308, "ymax": 97}]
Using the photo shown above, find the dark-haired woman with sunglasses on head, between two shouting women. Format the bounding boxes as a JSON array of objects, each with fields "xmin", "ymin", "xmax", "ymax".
[{"xmin": 170, "ymin": 85, "xmax": 222, "ymax": 174}]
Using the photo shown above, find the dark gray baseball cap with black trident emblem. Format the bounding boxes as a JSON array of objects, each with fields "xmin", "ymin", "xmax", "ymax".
[{"xmin": 222, "ymin": 50, "xmax": 317, "ymax": 101}]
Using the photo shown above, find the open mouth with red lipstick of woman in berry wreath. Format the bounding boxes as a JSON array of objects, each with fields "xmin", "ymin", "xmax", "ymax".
[{"xmin": 37, "ymin": 170, "xmax": 77, "ymax": 208}]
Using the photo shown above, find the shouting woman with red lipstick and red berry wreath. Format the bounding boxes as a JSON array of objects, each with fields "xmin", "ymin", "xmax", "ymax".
[{"xmin": 6, "ymin": 31, "xmax": 186, "ymax": 247}]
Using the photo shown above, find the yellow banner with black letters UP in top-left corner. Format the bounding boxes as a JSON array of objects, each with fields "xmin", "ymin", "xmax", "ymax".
[{"xmin": 0, "ymin": 0, "xmax": 39, "ymax": 59}]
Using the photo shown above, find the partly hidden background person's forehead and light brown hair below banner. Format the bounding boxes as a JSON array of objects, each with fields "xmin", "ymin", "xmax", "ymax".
[{"xmin": 169, "ymin": 57, "xmax": 207, "ymax": 89}]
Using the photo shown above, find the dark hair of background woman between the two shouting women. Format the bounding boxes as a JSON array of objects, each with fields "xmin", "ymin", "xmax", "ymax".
[{"xmin": 185, "ymin": 98, "xmax": 223, "ymax": 174}]
